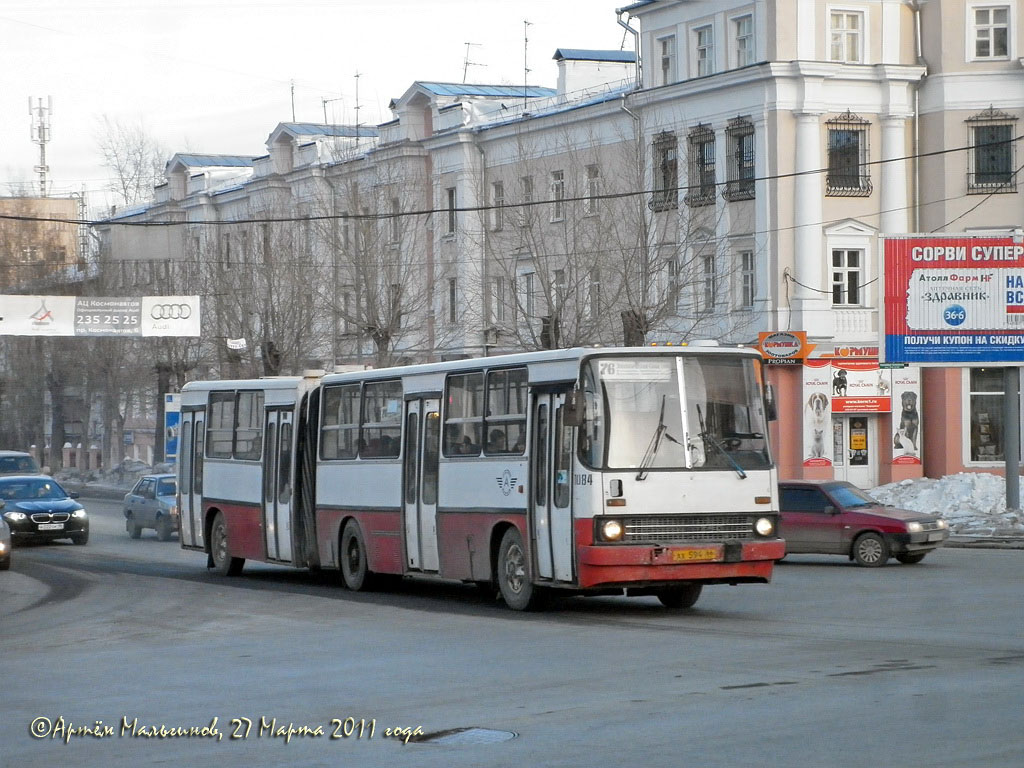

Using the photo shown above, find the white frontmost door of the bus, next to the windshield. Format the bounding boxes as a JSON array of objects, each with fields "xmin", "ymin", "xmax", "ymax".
[{"xmin": 529, "ymin": 392, "xmax": 573, "ymax": 582}]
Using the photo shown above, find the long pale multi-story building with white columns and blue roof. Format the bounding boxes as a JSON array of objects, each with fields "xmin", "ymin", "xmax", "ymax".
[{"xmin": 97, "ymin": 0, "xmax": 1024, "ymax": 485}]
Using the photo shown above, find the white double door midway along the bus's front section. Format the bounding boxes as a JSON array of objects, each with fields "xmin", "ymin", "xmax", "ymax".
[{"xmin": 401, "ymin": 398, "xmax": 441, "ymax": 571}]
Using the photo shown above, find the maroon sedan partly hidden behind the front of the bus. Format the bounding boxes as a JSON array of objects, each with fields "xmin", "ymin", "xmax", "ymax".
[{"xmin": 778, "ymin": 480, "xmax": 949, "ymax": 567}]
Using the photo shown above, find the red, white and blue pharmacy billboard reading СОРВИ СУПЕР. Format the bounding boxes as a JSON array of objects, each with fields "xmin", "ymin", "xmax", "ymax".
[{"xmin": 880, "ymin": 234, "xmax": 1024, "ymax": 366}]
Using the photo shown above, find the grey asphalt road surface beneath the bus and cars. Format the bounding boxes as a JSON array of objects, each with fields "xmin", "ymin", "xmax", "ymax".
[{"xmin": 0, "ymin": 500, "xmax": 1024, "ymax": 768}]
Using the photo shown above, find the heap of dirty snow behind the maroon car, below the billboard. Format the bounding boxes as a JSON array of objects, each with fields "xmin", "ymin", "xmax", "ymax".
[{"xmin": 867, "ymin": 472, "xmax": 1024, "ymax": 538}]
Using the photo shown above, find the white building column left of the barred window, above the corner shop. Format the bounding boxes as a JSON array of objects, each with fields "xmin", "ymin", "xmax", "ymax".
[{"xmin": 791, "ymin": 113, "xmax": 835, "ymax": 338}]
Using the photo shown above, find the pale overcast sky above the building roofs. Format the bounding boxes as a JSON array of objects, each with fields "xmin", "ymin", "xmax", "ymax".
[{"xmin": 0, "ymin": 0, "xmax": 633, "ymax": 206}]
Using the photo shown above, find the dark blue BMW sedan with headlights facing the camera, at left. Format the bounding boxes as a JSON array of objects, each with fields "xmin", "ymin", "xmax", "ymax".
[{"xmin": 0, "ymin": 475, "xmax": 89, "ymax": 544}]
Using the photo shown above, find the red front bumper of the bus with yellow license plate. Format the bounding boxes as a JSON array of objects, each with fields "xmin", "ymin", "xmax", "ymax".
[{"xmin": 579, "ymin": 539, "xmax": 785, "ymax": 589}]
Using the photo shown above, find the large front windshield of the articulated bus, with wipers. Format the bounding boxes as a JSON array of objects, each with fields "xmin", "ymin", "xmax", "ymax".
[{"xmin": 580, "ymin": 354, "xmax": 771, "ymax": 479}]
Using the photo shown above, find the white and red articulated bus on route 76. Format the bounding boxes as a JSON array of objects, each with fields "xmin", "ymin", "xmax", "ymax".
[{"xmin": 178, "ymin": 346, "xmax": 784, "ymax": 610}]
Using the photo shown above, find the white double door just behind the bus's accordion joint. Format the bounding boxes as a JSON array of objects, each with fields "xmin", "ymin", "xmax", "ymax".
[{"xmin": 263, "ymin": 409, "xmax": 295, "ymax": 562}]
